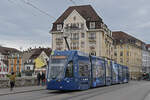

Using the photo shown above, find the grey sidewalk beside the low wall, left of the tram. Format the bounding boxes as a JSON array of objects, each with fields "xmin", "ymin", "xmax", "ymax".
[{"xmin": 0, "ymin": 86, "xmax": 46, "ymax": 96}]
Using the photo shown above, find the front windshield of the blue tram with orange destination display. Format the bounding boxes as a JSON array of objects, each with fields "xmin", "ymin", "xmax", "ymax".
[{"xmin": 49, "ymin": 56, "xmax": 67, "ymax": 79}]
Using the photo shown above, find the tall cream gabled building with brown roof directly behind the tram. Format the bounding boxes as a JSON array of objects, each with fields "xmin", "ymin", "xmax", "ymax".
[{"xmin": 50, "ymin": 5, "xmax": 114, "ymax": 59}]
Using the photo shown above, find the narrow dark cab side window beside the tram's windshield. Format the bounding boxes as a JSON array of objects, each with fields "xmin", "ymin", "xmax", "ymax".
[{"xmin": 65, "ymin": 61, "xmax": 73, "ymax": 78}]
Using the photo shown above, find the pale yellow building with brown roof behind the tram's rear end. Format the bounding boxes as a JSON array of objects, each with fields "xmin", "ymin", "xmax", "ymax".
[{"xmin": 112, "ymin": 31, "xmax": 143, "ymax": 79}]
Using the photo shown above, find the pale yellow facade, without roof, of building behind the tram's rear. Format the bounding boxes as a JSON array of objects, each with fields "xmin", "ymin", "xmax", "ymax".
[{"xmin": 114, "ymin": 43, "xmax": 142, "ymax": 79}]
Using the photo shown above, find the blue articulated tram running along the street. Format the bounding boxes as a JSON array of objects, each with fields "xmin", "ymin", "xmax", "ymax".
[{"xmin": 47, "ymin": 51, "xmax": 129, "ymax": 90}]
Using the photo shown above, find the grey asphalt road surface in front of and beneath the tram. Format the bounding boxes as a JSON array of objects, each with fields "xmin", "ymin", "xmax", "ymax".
[{"xmin": 0, "ymin": 81, "xmax": 150, "ymax": 100}]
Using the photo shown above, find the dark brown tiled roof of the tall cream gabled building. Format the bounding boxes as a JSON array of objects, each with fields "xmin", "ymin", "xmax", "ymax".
[{"xmin": 52, "ymin": 5, "xmax": 103, "ymax": 31}]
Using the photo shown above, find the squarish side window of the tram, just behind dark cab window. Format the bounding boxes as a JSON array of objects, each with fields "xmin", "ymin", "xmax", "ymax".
[{"xmin": 79, "ymin": 62, "xmax": 89, "ymax": 77}]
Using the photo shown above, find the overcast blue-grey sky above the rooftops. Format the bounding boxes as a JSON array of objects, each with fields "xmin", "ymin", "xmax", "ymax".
[{"xmin": 0, "ymin": 0, "xmax": 150, "ymax": 50}]
